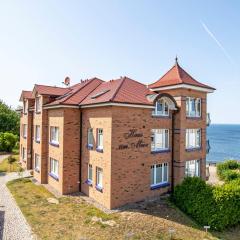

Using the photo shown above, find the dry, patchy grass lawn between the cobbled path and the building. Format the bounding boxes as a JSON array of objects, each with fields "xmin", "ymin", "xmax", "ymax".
[{"xmin": 7, "ymin": 178, "xmax": 240, "ymax": 240}]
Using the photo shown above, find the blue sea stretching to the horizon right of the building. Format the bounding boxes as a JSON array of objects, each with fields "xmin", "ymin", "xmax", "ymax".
[{"xmin": 207, "ymin": 124, "xmax": 240, "ymax": 163}]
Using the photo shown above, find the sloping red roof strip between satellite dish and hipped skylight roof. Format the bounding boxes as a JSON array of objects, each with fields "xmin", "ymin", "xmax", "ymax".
[{"xmin": 47, "ymin": 78, "xmax": 103, "ymax": 106}]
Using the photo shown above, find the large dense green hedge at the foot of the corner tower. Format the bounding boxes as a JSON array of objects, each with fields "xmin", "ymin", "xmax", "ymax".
[{"xmin": 172, "ymin": 177, "xmax": 240, "ymax": 231}]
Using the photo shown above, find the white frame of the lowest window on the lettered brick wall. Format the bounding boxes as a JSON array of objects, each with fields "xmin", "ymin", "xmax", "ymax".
[{"xmin": 150, "ymin": 163, "xmax": 169, "ymax": 187}]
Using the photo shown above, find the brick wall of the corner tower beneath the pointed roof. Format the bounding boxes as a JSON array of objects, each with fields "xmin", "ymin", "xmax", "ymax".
[{"xmin": 164, "ymin": 89, "xmax": 207, "ymax": 185}]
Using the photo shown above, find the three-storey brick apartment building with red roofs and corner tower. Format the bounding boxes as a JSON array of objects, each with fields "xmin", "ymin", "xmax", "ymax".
[{"xmin": 20, "ymin": 60, "xmax": 215, "ymax": 209}]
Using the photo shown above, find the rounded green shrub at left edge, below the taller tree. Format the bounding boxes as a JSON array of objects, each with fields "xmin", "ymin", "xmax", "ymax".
[{"xmin": 0, "ymin": 132, "xmax": 18, "ymax": 152}]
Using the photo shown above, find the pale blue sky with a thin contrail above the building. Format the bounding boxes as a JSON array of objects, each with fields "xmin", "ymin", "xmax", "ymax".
[{"xmin": 0, "ymin": 0, "xmax": 240, "ymax": 123}]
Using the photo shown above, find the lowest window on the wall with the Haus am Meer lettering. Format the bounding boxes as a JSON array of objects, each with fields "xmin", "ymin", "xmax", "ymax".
[{"xmin": 151, "ymin": 163, "xmax": 168, "ymax": 186}]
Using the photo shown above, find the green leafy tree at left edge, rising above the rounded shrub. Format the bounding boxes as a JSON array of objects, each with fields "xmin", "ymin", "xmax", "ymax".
[{"xmin": 0, "ymin": 100, "xmax": 20, "ymax": 136}]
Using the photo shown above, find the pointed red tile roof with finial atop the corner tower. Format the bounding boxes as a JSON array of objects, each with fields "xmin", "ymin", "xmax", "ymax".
[{"xmin": 149, "ymin": 62, "xmax": 215, "ymax": 90}]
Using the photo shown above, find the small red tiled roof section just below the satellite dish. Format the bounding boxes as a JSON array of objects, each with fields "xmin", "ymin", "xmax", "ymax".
[{"xmin": 32, "ymin": 84, "xmax": 70, "ymax": 96}]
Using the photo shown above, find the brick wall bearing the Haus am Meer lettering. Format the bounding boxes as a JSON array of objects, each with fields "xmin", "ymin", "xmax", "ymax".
[{"xmin": 111, "ymin": 107, "xmax": 172, "ymax": 208}]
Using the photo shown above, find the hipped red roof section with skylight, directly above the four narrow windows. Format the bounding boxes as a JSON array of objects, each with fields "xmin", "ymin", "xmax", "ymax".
[{"xmin": 80, "ymin": 77, "xmax": 153, "ymax": 105}]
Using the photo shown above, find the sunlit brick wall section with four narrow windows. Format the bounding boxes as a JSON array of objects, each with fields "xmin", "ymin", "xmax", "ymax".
[{"xmin": 81, "ymin": 107, "xmax": 112, "ymax": 208}]
